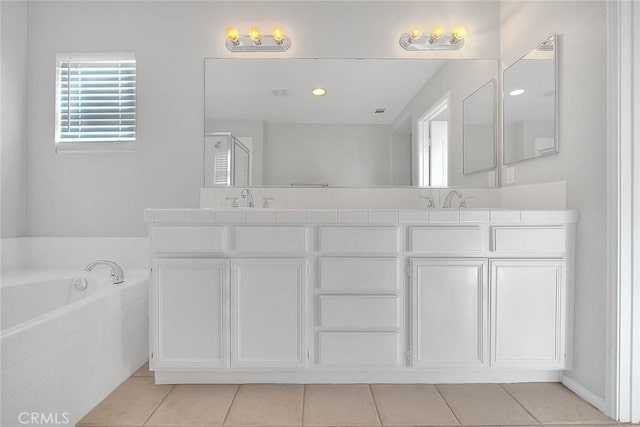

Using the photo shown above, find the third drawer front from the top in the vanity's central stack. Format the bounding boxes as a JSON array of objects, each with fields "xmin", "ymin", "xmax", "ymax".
[{"xmin": 318, "ymin": 295, "xmax": 400, "ymax": 329}]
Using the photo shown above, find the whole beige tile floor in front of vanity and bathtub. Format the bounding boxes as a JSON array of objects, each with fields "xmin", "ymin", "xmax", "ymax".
[{"xmin": 78, "ymin": 365, "xmax": 632, "ymax": 427}]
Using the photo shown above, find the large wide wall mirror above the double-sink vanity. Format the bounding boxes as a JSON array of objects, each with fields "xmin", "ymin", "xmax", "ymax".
[{"xmin": 205, "ymin": 58, "xmax": 498, "ymax": 187}]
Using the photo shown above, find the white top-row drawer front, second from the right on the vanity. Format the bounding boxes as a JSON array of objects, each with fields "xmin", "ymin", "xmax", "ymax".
[{"xmin": 409, "ymin": 227, "xmax": 484, "ymax": 254}]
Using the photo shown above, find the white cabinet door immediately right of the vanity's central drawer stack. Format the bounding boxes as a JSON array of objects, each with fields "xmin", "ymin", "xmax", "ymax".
[{"xmin": 411, "ymin": 260, "xmax": 488, "ymax": 368}]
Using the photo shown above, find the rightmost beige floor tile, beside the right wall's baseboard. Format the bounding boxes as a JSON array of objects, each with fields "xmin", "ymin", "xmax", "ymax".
[{"xmin": 503, "ymin": 383, "xmax": 614, "ymax": 425}]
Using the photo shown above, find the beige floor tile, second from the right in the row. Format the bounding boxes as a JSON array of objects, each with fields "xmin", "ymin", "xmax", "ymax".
[{"xmin": 437, "ymin": 384, "xmax": 538, "ymax": 426}]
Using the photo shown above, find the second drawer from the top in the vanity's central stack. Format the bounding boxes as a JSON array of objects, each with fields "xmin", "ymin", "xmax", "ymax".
[{"xmin": 318, "ymin": 258, "xmax": 399, "ymax": 291}]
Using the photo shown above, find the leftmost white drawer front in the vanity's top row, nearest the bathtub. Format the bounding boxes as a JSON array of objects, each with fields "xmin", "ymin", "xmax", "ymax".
[{"xmin": 151, "ymin": 227, "xmax": 226, "ymax": 252}]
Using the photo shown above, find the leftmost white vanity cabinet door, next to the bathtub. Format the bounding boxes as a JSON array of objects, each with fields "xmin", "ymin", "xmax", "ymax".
[{"xmin": 151, "ymin": 259, "xmax": 229, "ymax": 369}]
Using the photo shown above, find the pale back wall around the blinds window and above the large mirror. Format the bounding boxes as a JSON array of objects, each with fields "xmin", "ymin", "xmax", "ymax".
[{"xmin": 22, "ymin": 1, "xmax": 499, "ymax": 236}]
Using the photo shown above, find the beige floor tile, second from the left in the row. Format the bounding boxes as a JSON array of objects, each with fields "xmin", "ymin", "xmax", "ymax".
[{"xmin": 145, "ymin": 384, "xmax": 238, "ymax": 426}]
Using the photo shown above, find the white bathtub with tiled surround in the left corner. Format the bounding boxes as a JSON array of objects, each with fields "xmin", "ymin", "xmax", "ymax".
[{"xmin": 0, "ymin": 269, "xmax": 148, "ymax": 427}]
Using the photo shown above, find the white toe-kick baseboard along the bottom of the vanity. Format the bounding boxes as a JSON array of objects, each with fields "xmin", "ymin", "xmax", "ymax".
[{"xmin": 155, "ymin": 369, "xmax": 562, "ymax": 384}]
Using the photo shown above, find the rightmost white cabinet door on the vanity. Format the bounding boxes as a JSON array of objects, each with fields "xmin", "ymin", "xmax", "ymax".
[{"xmin": 491, "ymin": 260, "xmax": 566, "ymax": 369}]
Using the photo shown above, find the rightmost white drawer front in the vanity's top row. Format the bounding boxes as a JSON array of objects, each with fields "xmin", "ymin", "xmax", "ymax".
[{"xmin": 492, "ymin": 227, "xmax": 567, "ymax": 253}]
